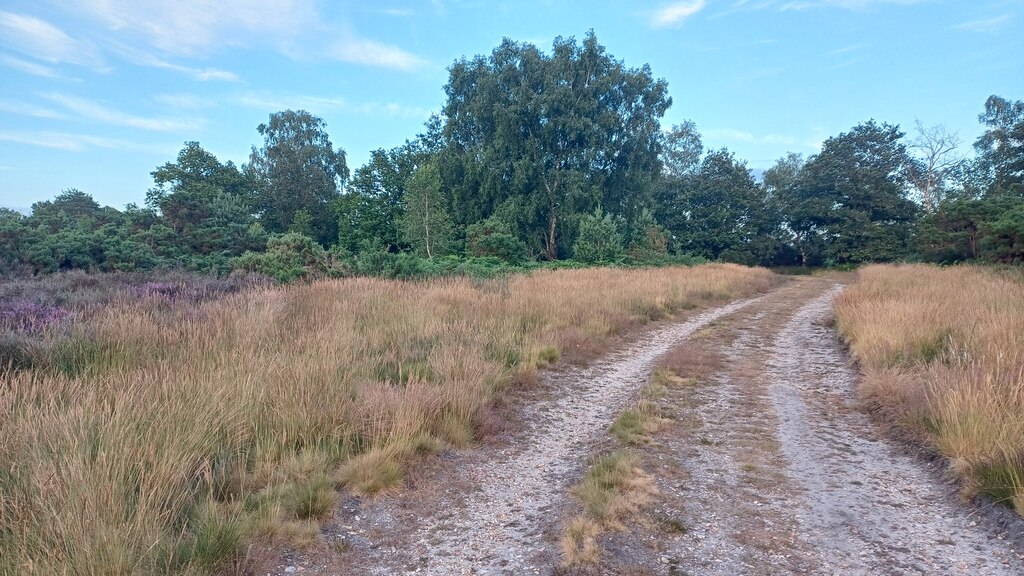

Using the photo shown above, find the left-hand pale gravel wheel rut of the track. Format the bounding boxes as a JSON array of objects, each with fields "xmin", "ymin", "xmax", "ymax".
[{"xmin": 272, "ymin": 296, "xmax": 763, "ymax": 575}]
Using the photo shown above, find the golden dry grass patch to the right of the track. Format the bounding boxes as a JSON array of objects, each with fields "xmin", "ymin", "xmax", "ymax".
[{"xmin": 836, "ymin": 265, "xmax": 1024, "ymax": 515}]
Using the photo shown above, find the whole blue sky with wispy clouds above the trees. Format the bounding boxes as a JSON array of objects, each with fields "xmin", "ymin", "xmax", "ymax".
[{"xmin": 0, "ymin": 0, "xmax": 1024, "ymax": 207}]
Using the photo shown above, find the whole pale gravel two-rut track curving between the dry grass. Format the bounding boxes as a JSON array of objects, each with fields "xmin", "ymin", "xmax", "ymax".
[{"xmin": 279, "ymin": 278, "xmax": 1024, "ymax": 575}]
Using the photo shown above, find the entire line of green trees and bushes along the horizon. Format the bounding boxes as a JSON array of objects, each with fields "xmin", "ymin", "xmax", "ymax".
[{"xmin": 0, "ymin": 33, "xmax": 1024, "ymax": 280}]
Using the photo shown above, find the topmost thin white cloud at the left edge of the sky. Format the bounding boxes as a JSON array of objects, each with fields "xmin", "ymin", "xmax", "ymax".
[{"xmin": 0, "ymin": 11, "xmax": 101, "ymax": 70}]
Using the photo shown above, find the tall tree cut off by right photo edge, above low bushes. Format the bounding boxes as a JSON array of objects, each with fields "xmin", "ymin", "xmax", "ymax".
[{"xmin": 974, "ymin": 95, "xmax": 1024, "ymax": 196}]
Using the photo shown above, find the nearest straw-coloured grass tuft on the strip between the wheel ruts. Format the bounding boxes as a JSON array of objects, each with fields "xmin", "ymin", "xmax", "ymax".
[{"xmin": 561, "ymin": 450, "xmax": 657, "ymax": 566}]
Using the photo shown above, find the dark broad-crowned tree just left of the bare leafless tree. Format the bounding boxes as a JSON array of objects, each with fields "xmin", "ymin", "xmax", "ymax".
[{"xmin": 779, "ymin": 120, "xmax": 918, "ymax": 264}]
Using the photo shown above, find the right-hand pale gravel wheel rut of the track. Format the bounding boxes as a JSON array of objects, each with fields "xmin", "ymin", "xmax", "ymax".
[{"xmin": 768, "ymin": 287, "xmax": 1024, "ymax": 575}]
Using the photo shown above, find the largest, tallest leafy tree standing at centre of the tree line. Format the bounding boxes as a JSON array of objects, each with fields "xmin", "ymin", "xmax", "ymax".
[{"xmin": 440, "ymin": 33, "xmax": 672, "ymax": 255}]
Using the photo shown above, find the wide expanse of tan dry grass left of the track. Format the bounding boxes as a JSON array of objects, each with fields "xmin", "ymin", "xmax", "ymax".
[{"xmin": 0, "ymin": 264, "xmax": 771, "ymax": 574}]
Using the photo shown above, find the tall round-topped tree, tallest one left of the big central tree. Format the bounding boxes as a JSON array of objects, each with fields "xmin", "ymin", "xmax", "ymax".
[{"xmin": 245, "ymin": 110, "xmax": 348, "ymax": 245}]
